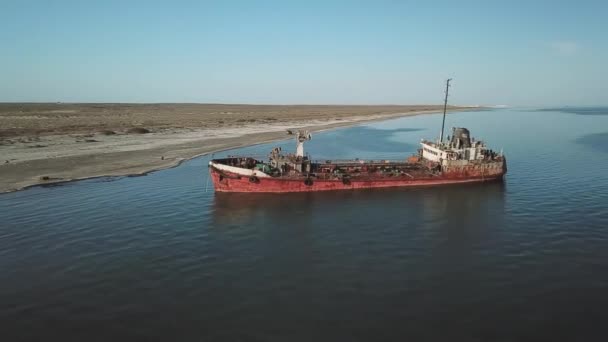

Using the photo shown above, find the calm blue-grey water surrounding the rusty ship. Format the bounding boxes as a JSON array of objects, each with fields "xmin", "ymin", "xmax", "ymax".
[{"xmin": 0, "ymin": 108, "xmax": 608, "ymax": 341}]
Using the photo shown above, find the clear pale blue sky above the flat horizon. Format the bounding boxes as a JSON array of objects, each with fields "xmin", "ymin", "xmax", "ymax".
[{"xmin": 0, "ymin": 0, "xmax": 608, "ymax": 106}]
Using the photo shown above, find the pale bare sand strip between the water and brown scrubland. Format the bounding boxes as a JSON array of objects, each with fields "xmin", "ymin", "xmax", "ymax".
[{"xmin": 0, "ymin": 107, "xmax": 482, "ymax": 193}]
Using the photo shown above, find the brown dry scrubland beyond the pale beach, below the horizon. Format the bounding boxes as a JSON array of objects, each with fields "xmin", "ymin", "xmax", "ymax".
[{"xmin": 0, "ymin": 103, "xmax": 454, "ymax": 138}]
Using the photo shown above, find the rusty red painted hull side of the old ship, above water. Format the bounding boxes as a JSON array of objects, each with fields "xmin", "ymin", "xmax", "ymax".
[{"xmin": 211, "ymin": 168, "xmax": 504, "ymax": 193}]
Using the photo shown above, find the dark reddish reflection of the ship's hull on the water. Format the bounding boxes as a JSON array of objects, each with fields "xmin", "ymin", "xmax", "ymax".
[{"xmin": 211, "ymin": 182, "xmax": 506, "ymax": 226}]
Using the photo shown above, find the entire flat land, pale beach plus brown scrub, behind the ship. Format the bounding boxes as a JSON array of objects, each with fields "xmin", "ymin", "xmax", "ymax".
[{"xmin": 0, "ymin": 103, "xmax": 471, "ymax": 192}]
